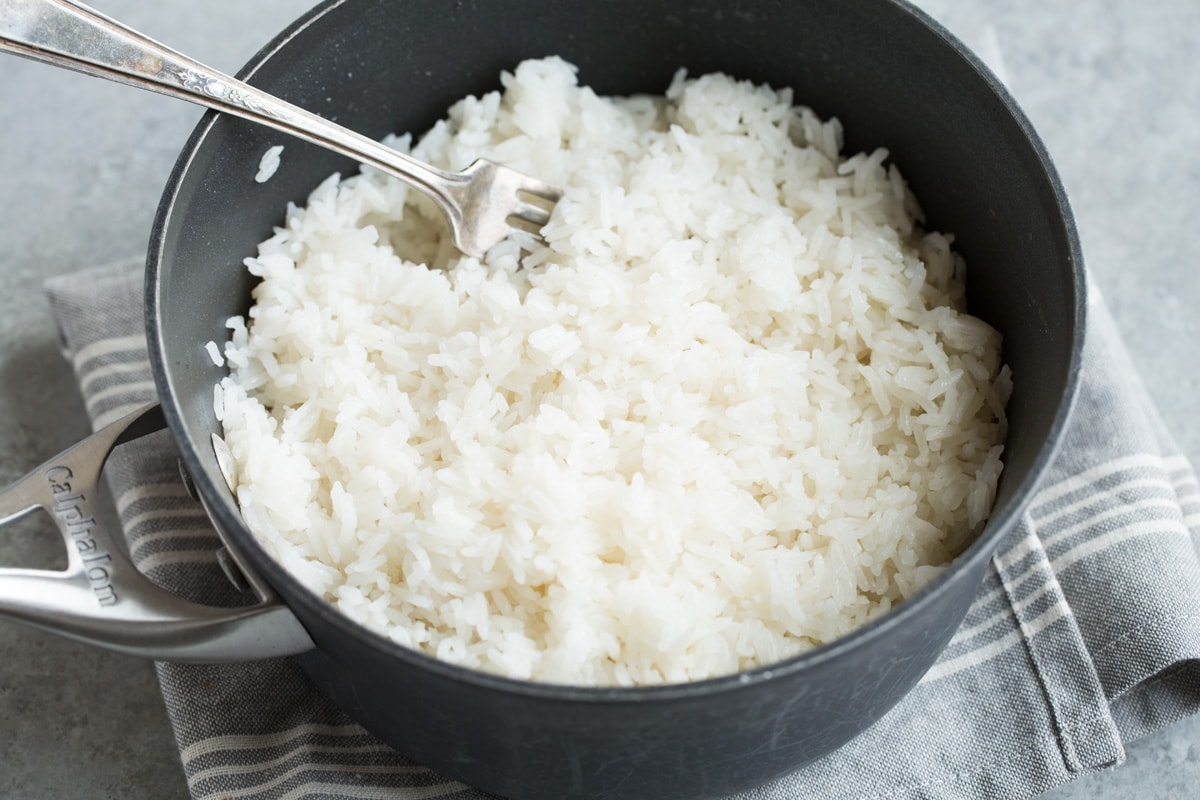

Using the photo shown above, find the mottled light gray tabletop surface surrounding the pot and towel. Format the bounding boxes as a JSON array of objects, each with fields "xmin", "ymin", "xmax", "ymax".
[{"xmin": 0, "ymin": 0, "xmax": 1200, "ymax": 800}]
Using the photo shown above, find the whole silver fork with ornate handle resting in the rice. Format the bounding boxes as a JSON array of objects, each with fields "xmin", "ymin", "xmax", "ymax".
[{"xmin": 0, "ymin": 0, "xmax": 562, "ymax": 257}]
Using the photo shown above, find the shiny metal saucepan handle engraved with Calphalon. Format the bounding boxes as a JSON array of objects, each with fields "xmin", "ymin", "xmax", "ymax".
[{"xmin": 0, "ymin": 405, "xmax": 313, "ymax": 662}]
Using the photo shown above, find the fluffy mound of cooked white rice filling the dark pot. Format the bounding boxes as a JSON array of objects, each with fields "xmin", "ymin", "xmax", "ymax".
[{"xmin": 217, "ymin": 59, "xmax": 1010, "ymax": 685}]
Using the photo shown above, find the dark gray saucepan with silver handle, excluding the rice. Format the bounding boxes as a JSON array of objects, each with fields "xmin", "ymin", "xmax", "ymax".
[{"xmin": 0, "ymin": 0, "xmax": 1085, "ymax": 800}]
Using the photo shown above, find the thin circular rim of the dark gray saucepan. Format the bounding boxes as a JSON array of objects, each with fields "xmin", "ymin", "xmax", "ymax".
[{"xmin": 144, "ymin": 0, "xmax": 1087, "ymax": 703}]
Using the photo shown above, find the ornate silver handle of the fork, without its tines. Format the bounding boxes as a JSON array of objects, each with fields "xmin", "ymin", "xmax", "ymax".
[{"xmin": 0, "ymin": 0, "xmax": 468, "ymax": 221}]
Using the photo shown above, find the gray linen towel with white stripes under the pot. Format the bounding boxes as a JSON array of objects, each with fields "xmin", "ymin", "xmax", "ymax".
[{"xmin": 47, "ymin": 263, "xmax": 1200, "ymax": 800}]
